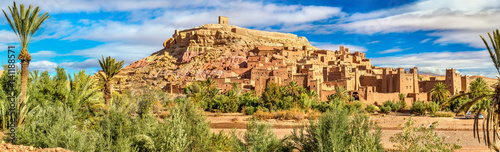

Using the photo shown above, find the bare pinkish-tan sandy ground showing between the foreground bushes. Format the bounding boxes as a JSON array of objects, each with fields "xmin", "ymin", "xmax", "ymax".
[{"xmin": 206, "ymin": 112, "xmax": 492, "ymax": 152}]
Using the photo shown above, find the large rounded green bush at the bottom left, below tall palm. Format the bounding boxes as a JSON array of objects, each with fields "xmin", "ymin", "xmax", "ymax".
[{"xmin": 15, "ymin": 104, "xmax": 96, "ymax": 151}]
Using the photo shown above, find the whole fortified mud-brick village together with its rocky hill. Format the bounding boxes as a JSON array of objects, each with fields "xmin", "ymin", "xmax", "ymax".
[{"xmin": 115, "ymin": 16, "xmax": 471, "ymax": 104}]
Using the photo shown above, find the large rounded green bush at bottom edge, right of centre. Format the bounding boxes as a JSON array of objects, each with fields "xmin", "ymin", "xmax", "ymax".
[{"xmin": 286, "ymin": 107, "xmax": 383, "ymax": 151}]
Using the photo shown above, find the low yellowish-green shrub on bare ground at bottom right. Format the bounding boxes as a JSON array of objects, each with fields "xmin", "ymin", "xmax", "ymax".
[{"xmin": 390, "ymin": 118, "xmax": 461, "ymax": 151}]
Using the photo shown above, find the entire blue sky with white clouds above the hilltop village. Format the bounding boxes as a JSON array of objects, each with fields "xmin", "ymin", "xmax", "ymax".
[{"xmin": 0, "ymin": 0, "xmax": 500, "ymax": 77}]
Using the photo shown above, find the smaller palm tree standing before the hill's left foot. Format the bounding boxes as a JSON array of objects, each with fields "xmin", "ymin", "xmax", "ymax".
[{"xmin": 97, "ymin": 56, "xmax": 124, "ymax": 105}]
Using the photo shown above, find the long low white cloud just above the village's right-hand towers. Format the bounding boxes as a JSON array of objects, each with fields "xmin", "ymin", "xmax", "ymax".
[{"xmin": 371, "ymin": 50, "xmax": 498, "ymax": 78}]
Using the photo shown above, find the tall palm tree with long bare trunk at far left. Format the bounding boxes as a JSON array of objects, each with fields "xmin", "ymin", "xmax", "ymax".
[{"xmin": 2, "ymin": 2, "xmax": 49, "ymax": 105}]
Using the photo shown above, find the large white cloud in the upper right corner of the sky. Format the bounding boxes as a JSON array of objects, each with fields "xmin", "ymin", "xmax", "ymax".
[{"xmin": 328, "ymin": 0, "xmax": 500, "ymax": 48}]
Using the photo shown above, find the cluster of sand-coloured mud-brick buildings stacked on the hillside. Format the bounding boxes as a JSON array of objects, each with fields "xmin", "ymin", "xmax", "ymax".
[{"xmin": 164, "ymin": 17, "xmax": 470, "ymax": 104}]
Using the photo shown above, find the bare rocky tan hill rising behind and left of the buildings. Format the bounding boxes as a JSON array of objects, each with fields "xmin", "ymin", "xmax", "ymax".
[{"xmin": 114, "ymin": 17, "xmax": 317, "ymax": 90}]
